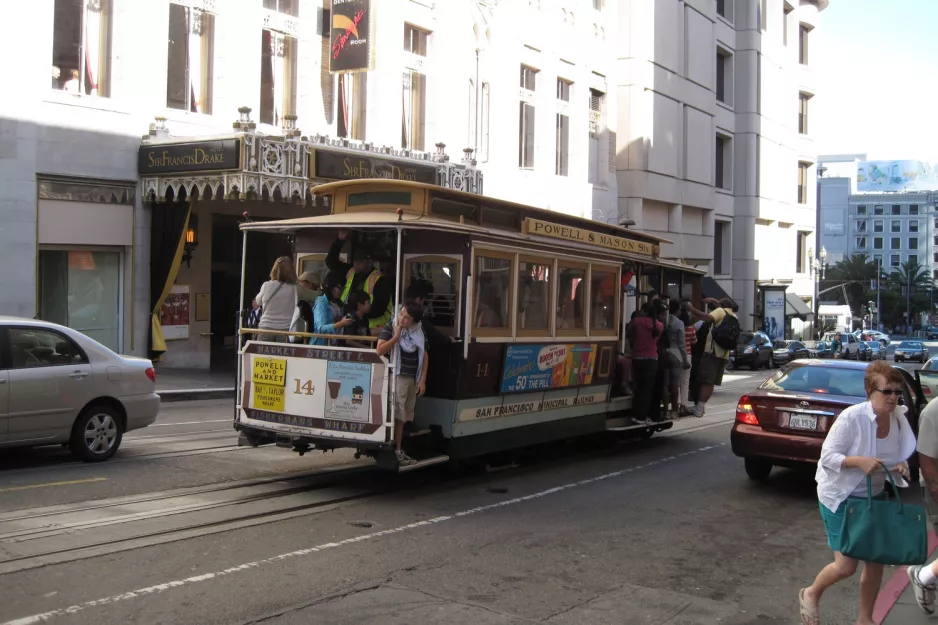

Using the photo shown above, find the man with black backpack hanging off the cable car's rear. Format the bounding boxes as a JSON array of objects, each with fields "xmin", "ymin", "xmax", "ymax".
[{"xmin": 687, "ymin": 297, "xmax": 739, "ymax": 418}]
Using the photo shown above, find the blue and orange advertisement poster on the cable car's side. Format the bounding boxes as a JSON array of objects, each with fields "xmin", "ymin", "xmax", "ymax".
[{"xmin": 502, "ymin": 343, "xmax": 596, "ymax": 393}]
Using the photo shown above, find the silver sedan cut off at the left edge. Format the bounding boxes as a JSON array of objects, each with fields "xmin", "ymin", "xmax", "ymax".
[{"xmin": 0, "ymin": 317, "xmax": 160, "ymax": 462}]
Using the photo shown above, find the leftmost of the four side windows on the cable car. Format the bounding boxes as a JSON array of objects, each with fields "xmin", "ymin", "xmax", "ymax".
[{"xmin": 473, "ymin": 251, "xmax": 513, "ymax": 336}]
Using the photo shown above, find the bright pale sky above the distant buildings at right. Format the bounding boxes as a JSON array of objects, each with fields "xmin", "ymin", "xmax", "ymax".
[{"xmin": 809, "ymin": 0, "xmax": 938, "ymax": 162}]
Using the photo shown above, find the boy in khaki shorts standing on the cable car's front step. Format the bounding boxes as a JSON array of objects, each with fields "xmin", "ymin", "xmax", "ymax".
[{"xmin": 377, "ymin": 302, "xmax": 428, "ymax": 466}]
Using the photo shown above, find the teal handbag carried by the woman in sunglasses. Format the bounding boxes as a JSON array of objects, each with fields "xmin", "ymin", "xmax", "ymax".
[{"xmin": 840, "ymin": 465, "xmax": 928, "ymax": 565}]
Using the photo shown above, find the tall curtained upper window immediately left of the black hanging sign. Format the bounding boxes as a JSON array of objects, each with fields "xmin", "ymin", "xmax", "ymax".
[{"xmin": 260, "ymin": 28, "xmax": 296, "ymax": 126}]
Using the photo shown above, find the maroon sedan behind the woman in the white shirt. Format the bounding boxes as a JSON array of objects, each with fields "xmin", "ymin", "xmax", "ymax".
[{"xmin": 730, "ymin": 360, "xmax": 930, "ymax": 481}]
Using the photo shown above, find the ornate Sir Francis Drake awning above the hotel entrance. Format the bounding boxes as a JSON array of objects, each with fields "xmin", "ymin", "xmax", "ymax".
[{"xmin": 137, "ymin": 107, "xmax": 482, "ymax": 204}]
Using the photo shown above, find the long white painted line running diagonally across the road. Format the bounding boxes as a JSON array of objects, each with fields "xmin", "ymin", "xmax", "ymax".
[{"xmin": 0, "ymin": 443, "xmax": 726, "ymax": 625}]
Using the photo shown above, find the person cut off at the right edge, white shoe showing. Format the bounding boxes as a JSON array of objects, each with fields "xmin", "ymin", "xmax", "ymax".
[{"xmin": 906, "ymin": 390, "xmax": 938, "ymax": 615}]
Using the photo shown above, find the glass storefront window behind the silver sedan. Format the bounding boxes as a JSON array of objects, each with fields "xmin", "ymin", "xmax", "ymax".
[{"xmin": 39, "ymin": 250, "xmax": 122, "ymax": 352}]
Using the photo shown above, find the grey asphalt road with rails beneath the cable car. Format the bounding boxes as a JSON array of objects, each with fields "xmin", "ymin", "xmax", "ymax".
[{"xmin": 0, "ymin": 360, "xmax": 928, "ymax": 625}]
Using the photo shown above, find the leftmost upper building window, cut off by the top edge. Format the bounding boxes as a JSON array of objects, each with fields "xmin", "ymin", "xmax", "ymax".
[{"xmin": 52, "ymin": 0, "xmax": 111, "ymax": 98}]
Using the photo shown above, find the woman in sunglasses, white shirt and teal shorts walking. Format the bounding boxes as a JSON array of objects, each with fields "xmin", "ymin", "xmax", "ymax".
[{"xmin": 798, "ymin": 360, "xmax": 915, "ymax": 625}]
